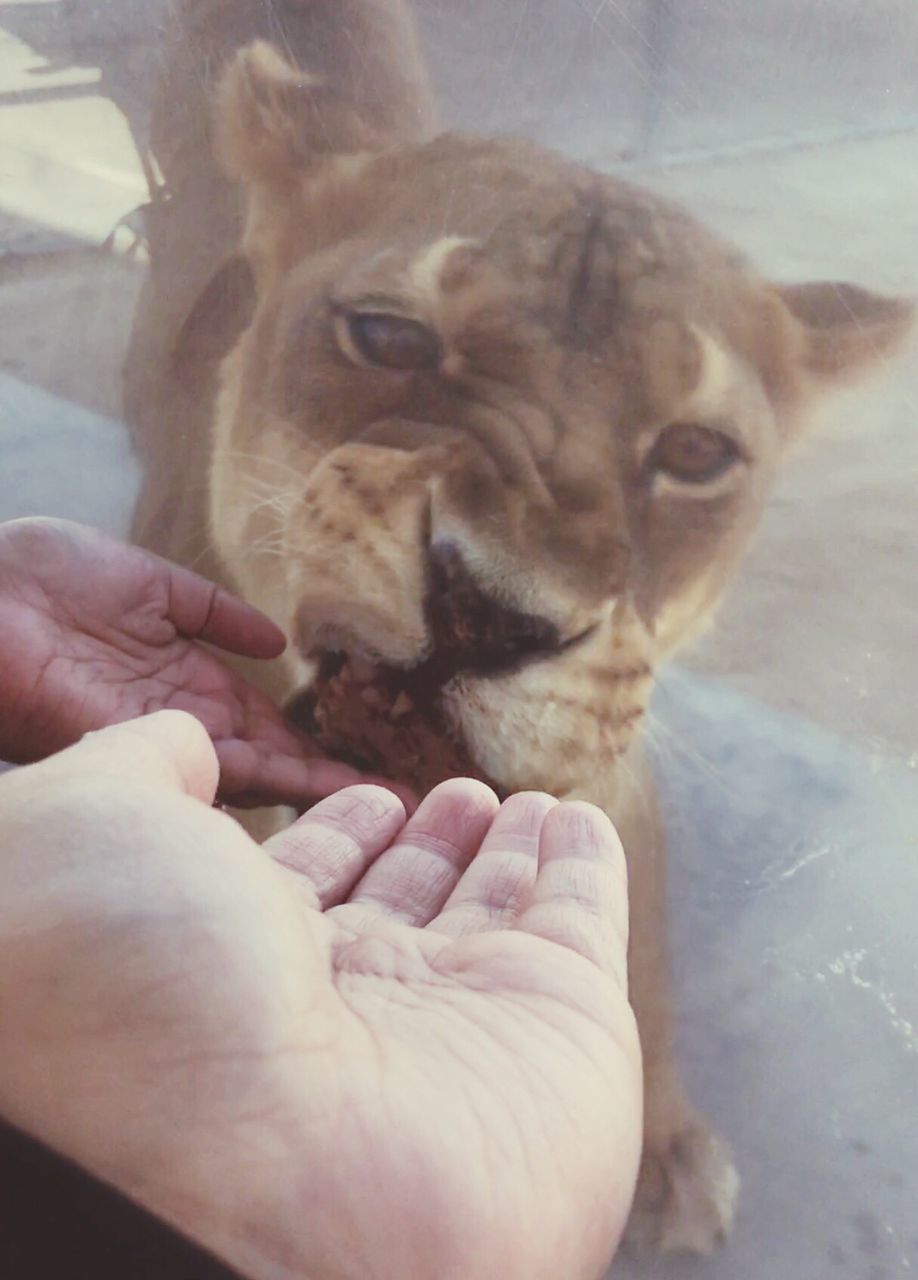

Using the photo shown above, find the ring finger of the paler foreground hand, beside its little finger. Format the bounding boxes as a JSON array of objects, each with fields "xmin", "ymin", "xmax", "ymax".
[{"xmin": 431, "ymin": 791, "xmax": 558, "ymax": 937}]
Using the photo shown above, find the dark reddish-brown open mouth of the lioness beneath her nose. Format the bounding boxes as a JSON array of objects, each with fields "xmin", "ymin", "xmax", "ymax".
[{"xmin": 287, "ymin": 654, "xmax": 492, "ymax": 796}]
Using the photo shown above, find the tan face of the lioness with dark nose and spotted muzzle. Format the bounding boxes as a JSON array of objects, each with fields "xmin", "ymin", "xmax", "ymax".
[{"xmin": 211, "ymin": 50, "xmax": 904, "ymax": 794}]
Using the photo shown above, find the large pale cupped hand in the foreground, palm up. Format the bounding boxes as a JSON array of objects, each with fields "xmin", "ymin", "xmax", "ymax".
[{"xmin": 0, "ymin": 713, "xmax": 641, "ymax": 1280}]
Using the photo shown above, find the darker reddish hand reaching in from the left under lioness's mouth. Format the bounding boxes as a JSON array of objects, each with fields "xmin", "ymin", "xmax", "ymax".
[{"xmin": 0, "ymin": 520, "xmax": 398, "ymax": 806}]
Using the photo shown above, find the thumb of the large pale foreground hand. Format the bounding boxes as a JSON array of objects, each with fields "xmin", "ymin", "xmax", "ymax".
[{"xmin": 61, "ymin": 710, "xmax": 220, "ymax": 804}]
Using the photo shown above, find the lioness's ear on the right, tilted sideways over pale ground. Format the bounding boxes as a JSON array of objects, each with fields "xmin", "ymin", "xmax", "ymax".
[{"xmin": 777, "ymin": 282, "xmax": 914, "ymax": 384}]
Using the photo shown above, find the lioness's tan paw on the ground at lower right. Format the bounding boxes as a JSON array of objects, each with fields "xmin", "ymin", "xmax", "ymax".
[{"xmin": 626, "ymin": 1120, "xmax": 740, "ymax": 1253}]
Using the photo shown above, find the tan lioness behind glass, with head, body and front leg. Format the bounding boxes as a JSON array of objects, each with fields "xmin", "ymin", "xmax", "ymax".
[{"xmin": 128, "ymin": 0, "xmax": 910, "ymax": 1252}]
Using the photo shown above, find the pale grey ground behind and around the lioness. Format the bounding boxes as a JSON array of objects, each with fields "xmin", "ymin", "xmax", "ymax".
[{"xmin": 0, "ymin": 0, "xmax": 918, "ymax": 1280}]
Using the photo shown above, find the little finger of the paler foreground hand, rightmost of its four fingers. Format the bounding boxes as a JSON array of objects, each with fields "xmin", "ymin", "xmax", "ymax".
[{"xmin": 515, "ymin": 800, "xmax": 627, "ymax": 991}]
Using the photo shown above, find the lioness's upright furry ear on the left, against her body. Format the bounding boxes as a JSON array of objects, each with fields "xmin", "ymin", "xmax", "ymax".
[{"xmin": 215, "ymin": 41, "xmax": 385, "ymax": 184}]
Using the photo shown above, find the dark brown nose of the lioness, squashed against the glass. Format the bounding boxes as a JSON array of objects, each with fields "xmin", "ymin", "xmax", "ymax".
[{"xmin": 429, "ymin": 540, "xmax": 561, "ymax": 671}]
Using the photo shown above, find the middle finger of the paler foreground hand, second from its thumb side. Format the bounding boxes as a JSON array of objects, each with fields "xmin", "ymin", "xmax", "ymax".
[{"xmin": 335, "ymin": 778, "xmax": 498, "ymax": 925}]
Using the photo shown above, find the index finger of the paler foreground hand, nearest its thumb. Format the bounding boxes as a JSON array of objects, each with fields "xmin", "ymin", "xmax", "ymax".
[{"xmin": 264, "ymin": 786, "xmax": 405, "ymax": 910}]
